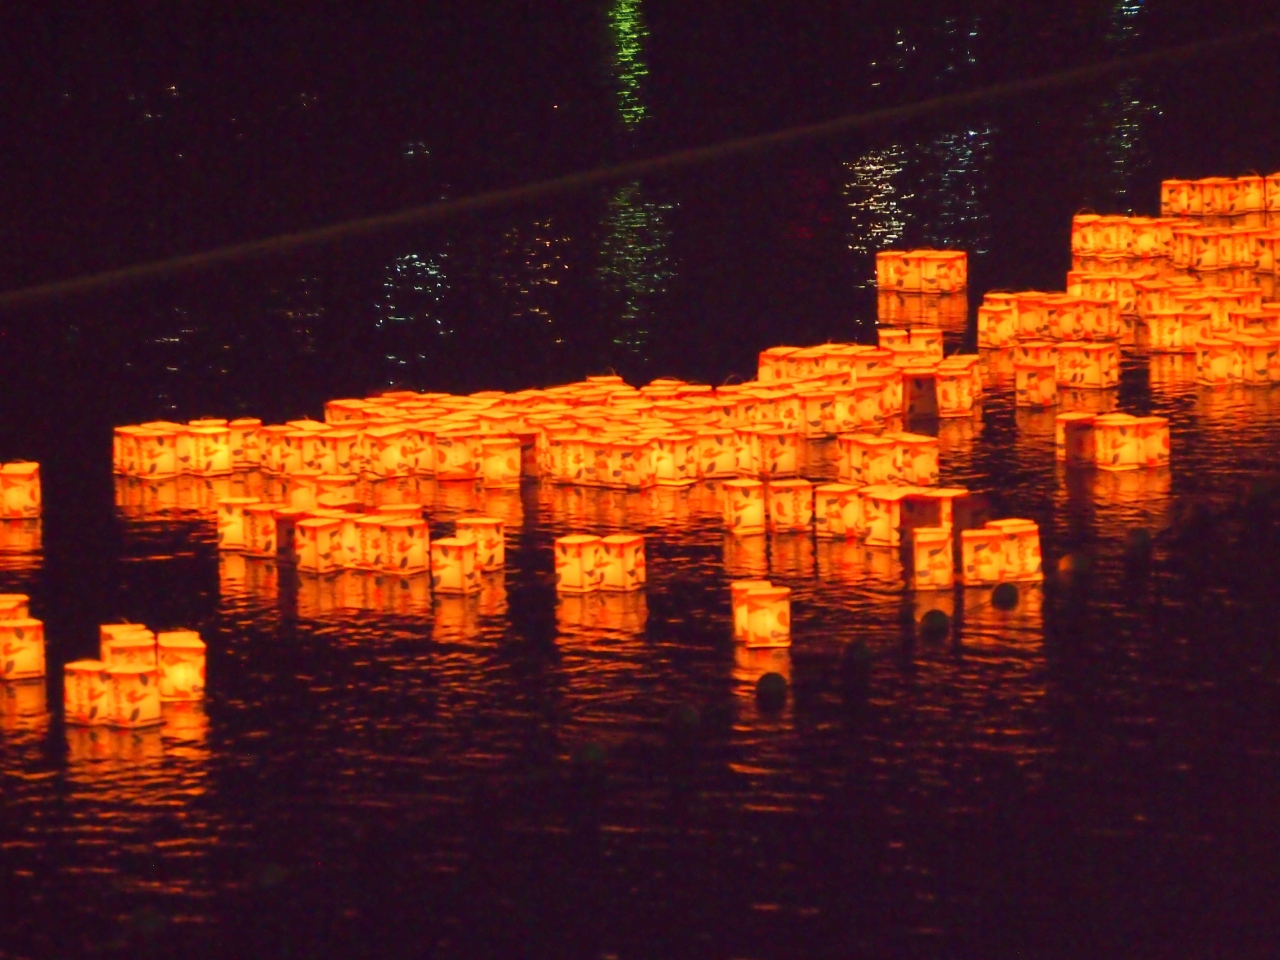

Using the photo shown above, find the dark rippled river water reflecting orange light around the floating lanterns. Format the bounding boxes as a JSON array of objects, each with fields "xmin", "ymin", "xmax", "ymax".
[{"xmin": 0, "ymin": 0, "xmax": 1280, "ymax": 957}]
